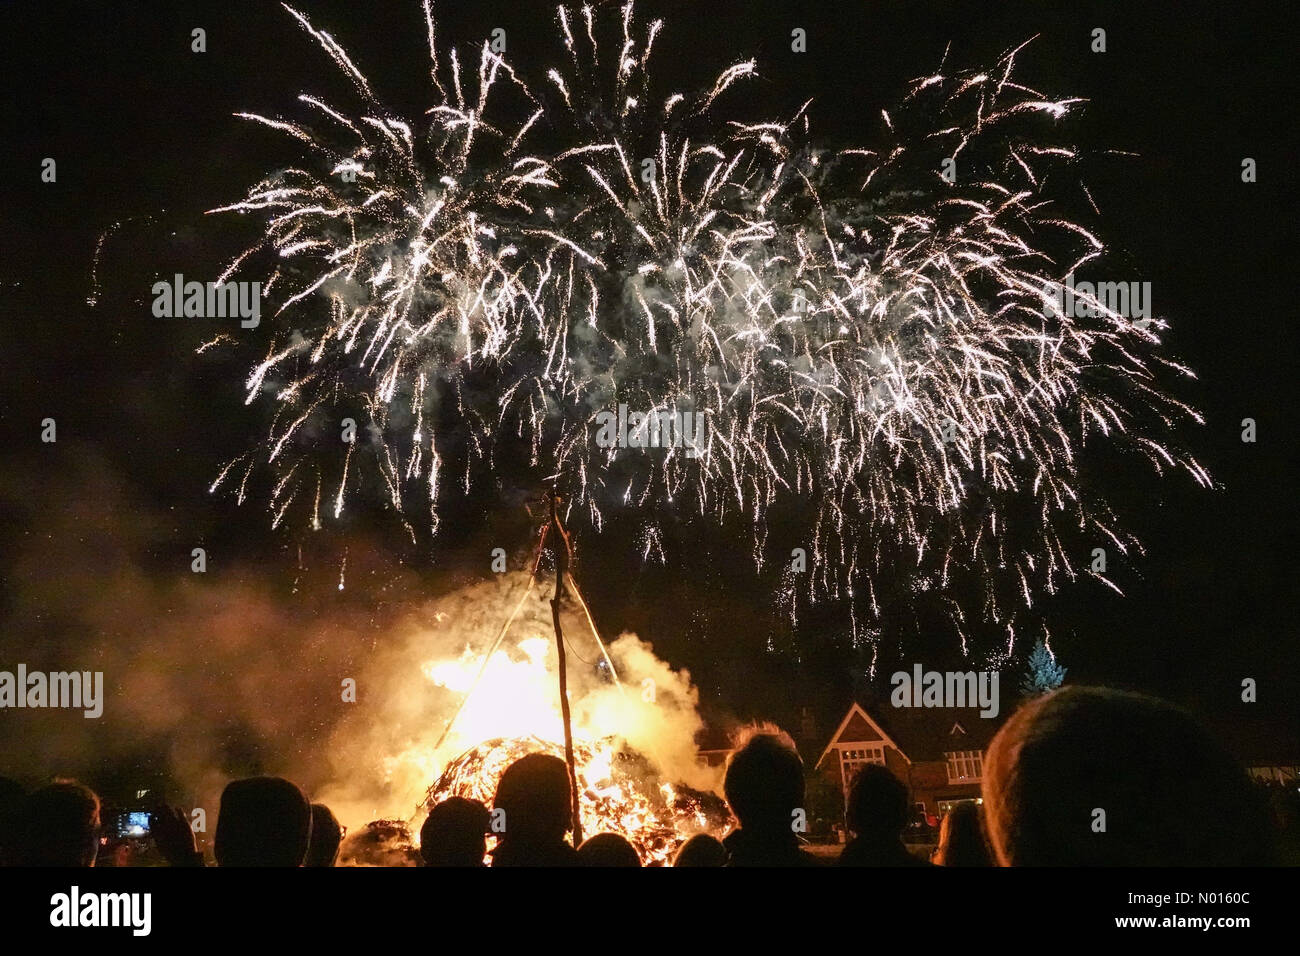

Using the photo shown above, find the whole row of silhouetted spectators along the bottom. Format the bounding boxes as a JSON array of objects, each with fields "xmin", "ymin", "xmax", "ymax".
[{"xmin": 0, "ymin": 687, "xmax": 1300, "ymax": 868}]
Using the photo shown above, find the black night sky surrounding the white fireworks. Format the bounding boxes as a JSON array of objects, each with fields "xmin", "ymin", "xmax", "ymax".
[{"xmin": 0, "ymin": 0, "xmax": 1300, "ymax": 790}]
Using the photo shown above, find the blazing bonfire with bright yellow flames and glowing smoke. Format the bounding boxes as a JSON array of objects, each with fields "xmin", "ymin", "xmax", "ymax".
[{"xmin": 313, "ymin": 571, "xmax": 725, "ymax": 842}]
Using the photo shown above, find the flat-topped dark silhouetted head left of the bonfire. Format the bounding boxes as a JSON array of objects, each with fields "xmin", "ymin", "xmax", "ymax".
[{"xmin": 213, "ymin": 777, "xmax": 312, "ymax": 866}]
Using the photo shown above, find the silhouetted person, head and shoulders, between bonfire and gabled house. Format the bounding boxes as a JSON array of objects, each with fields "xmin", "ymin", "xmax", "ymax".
[{"xmin": 723, "ymin": 731, "xmax": 818, "ymax": 866}]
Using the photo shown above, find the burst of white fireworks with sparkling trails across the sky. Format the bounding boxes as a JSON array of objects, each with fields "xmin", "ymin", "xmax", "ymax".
[{"xmin": 205, "ymin": 4, "xmax": 1210, "ymax": 654}]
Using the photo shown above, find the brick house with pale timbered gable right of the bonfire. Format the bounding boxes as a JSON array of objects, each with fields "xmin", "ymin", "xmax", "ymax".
[{"xmin": 816, "ymin": 702, "xmax": 1000, "ymax": 826}]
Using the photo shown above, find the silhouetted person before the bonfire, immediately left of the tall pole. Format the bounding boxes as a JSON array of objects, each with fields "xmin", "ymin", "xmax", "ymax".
[{"xmin": 491, "ymin": 753, "xmax": 579, "ymax": 866}]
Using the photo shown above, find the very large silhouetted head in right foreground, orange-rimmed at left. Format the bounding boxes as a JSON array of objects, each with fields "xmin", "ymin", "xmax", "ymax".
[{"xmin": 984, "ymin": 687, "xmax": 1270, "ymax": 866}]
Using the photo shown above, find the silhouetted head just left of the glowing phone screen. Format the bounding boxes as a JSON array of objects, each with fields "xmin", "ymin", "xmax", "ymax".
[{"xmin": 14, "ymin": 780, "xmax": 99, "ymax": 866}]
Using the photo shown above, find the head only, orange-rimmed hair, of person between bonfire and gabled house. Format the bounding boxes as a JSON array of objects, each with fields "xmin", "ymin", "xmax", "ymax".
[{"xmin": 723, "ymin": 731, "xmax": 803, "ymax": 834}]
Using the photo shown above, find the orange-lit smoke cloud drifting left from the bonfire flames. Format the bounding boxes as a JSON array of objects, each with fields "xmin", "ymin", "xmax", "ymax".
[{"xmin": 0, "ymin": 447, "xmax": 715, "ymax": 834}]
